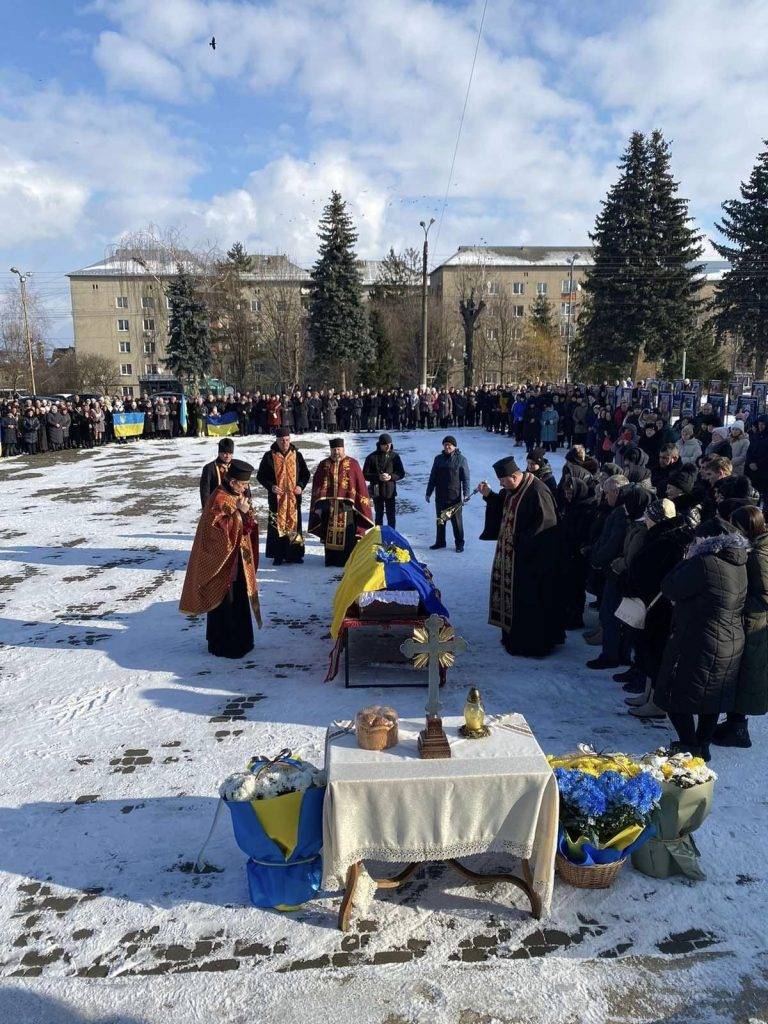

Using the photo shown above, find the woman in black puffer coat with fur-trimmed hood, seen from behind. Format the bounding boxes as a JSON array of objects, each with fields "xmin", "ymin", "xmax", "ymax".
[{"xmin": 653, "ymin": 532, "xmax": 750, "ymax": 761}]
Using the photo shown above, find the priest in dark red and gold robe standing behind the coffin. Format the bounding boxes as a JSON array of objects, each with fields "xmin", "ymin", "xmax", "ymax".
[{"xmin": 309, "ymin": 437, "xmax": 374, "ymax": 566}]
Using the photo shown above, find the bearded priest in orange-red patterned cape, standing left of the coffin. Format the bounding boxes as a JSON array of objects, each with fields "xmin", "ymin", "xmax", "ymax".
[{"xmin": 179, "ymin": 459, "xmax": 261, "ymax": 657}]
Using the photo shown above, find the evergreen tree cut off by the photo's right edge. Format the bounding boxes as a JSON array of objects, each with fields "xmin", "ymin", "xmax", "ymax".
[{"xmin": 715, "ymin": 139, "xmax": 768, "ymax": 380}]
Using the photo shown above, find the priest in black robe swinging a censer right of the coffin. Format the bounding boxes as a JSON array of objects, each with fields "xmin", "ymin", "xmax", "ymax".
[{"xmin": 480, "ymin": 456, "xmax": 565, "ymax": 657}]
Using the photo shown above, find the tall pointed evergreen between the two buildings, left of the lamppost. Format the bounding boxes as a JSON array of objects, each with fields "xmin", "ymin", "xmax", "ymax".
[{"xmin": 309, "ymin": 191, "xmax": 375, "ymax": 386}]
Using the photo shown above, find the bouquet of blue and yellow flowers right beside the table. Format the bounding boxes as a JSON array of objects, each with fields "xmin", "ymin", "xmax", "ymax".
[{"xmin": 549, "ymin": 748, "xmax": 662, "ymax": 881}]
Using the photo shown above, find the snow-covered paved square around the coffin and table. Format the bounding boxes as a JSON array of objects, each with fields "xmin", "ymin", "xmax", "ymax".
[{"xmin": 0, "ymin": 430, "xmax": 768, "ymax": 1024}]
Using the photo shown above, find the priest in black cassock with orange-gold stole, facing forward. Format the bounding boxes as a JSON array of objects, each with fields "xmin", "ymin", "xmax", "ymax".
[{"xmin": 256, "ymin": 427, "xmax": 310, "ymax": 565}]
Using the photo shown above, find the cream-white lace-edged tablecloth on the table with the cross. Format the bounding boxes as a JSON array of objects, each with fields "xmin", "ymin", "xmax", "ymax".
[{"xmin": 323, "ymin": 715, "xmax": 558, "ymax": 913}]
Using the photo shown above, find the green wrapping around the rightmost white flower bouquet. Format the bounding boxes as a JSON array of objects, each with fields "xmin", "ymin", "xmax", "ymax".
[{"xmin": 632, "ymin": 780, "xmax": 715, "ymax": 881}]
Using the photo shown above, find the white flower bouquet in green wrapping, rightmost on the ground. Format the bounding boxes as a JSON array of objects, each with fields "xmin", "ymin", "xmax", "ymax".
[{"xmin": 632, "ymin": 748, "xmax": 717, "ymax": 880}]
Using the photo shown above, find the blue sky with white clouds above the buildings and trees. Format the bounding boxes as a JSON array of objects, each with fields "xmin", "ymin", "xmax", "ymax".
[{"xmin": 0, "ymin": 0, "xmax": 768, "ymax": 343}]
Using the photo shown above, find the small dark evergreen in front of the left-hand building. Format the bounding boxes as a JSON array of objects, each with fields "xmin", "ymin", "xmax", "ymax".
[{"xmin": 164, "ymin": 263, "xmax": 212, "ymax": 389}]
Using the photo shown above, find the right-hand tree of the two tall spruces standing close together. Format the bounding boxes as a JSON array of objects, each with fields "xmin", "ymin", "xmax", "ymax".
[{"xmin": 644, "ymin": 131, "xmax": 707, "ymax": 368}]
